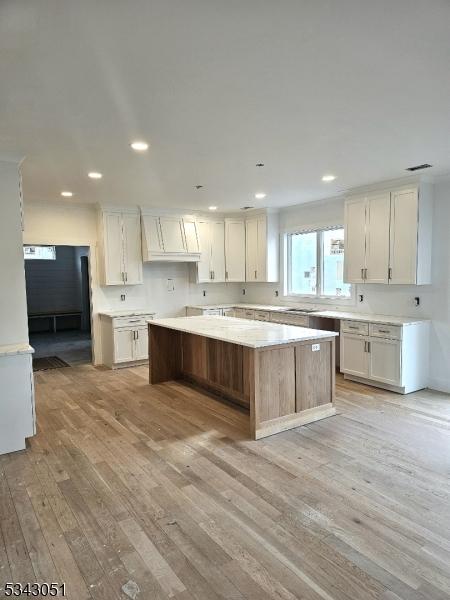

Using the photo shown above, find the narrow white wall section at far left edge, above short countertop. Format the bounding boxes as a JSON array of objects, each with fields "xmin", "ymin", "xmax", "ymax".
[{"xmin": 0, "ymin": 162, "xmax": 28, "ymax": 345}]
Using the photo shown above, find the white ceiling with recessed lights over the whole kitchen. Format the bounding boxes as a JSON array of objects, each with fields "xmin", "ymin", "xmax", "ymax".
[{"xmin": 0, "ymin": 0, "xmax": 450, "ymax": 210}]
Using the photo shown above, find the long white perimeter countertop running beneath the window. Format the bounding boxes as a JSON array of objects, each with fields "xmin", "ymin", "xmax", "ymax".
[{"xmin": 188, "ymin": 302, "xmax": 428, "ymax": 325}]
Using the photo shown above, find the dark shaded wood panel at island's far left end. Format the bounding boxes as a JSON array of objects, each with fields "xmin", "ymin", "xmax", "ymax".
[{"xmin": 148, "ymin": 324, "xmax": 181, "ymax": 383}]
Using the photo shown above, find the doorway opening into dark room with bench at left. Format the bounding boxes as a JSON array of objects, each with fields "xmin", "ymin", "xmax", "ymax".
[{"xmin": 24, "ymin": 245, "xmax": 92, "ymax": 370}]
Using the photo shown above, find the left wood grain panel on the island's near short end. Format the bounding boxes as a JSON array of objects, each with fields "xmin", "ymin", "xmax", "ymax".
[{"xmin": 258, "ymin": 346, "xmax": 295, "ymax": 422}]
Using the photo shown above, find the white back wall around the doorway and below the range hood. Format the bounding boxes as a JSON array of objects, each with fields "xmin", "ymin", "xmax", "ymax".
[{"xmin": 24, "ymin": 202, "xmax": 241, "ymax": 364}]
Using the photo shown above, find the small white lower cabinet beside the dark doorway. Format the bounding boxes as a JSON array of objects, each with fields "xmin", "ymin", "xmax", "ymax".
[{"xmin": 101, "ymin": 314, "xmax": 153, "ymax": 369}]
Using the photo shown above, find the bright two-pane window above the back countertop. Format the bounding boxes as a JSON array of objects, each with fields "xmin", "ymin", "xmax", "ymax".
[{"xmin": 287, "ymin": 227, "xmax": 351, "ymax": 298}]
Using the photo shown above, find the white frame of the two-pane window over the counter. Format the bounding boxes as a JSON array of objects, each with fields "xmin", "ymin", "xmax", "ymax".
[{"xmin": 283, "ymin": 225, "xmax": 356, "ymax": 305}]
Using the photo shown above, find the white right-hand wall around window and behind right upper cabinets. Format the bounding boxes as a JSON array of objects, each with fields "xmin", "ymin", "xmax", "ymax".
[{"xmin": 241, "ymin": 185, "xmax": 450, "ymax": 392}]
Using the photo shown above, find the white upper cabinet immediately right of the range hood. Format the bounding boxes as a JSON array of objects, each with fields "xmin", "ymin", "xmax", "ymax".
[{"xmin": 197, "ymin": 220, "xmax": 225, "ymax": 283}]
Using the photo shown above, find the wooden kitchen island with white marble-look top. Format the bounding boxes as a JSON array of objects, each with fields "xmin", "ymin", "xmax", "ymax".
[{"xmin": 148, "ymin": 316, "xmax": 337, "ymax": 439}]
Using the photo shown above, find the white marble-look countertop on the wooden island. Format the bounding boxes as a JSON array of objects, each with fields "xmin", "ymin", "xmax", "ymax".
[{"xmin": 148, "ymin": 315, "xmax": 338, "ymax": 348}]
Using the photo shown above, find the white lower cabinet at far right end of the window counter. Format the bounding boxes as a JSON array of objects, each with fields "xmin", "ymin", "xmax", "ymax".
[{"xmin": 340, "ymin": 321, "xmax": 429, "ymax": 394}]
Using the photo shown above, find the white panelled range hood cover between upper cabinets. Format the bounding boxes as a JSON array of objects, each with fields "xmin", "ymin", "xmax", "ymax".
[{"xmin": 141, "ymin": 209, "xmax": 200, "ymax": 262}]
